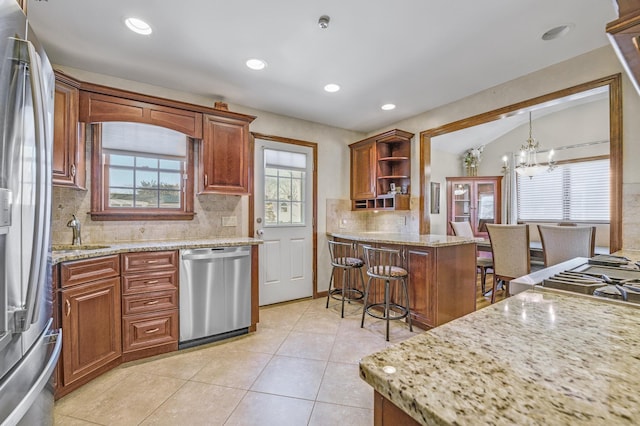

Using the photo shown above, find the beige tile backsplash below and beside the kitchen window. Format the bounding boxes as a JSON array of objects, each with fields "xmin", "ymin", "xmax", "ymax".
[{"xmin": 52, "ymin": 187, "xmax": 244, "ymax": 244}]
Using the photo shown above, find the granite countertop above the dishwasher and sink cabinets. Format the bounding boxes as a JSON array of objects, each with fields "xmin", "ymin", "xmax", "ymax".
[{"xmin": 51, "ymin": 237, "xmax": 262, "ymax": 265}]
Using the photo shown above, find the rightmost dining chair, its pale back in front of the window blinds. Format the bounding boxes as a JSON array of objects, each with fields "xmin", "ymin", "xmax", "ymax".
[{"xmin": 538, "ymin": 225, "xmax": 596, "ymax": 266}]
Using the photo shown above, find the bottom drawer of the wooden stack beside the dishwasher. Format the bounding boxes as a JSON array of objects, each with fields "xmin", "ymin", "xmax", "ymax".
[{"xmin": 122, "ymin": 309, "xmax": 178, "ymax": 352}]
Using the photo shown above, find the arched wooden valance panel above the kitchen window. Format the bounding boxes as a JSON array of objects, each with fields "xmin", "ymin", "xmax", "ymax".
[{"xmin": 80, "ymin": 91, "xmax": 202, "ymax": 138}]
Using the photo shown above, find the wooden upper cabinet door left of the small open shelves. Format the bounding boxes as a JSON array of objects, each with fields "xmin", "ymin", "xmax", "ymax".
[{"xmin": 351, "ymin": 141, "xmax": 376, "ymax": 200}]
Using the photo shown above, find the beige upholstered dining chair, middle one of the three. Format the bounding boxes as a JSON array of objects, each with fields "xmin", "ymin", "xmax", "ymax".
[{"xmin": 487, "ymin": 224, "xmax": 531, "ymax": 303}]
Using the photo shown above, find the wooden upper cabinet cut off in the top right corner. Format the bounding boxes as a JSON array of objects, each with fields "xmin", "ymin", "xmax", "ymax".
[{"xmin": 607, "ymin": 0, "xmax": 640, "ymax": 94}]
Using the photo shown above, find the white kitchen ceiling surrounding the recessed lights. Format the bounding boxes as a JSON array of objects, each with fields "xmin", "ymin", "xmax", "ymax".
[{"xmin": 28, "ymin": 0, "xmax": 616, "ymax": 132}]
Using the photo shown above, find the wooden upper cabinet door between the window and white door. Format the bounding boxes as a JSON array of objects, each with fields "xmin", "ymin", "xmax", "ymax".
[{"xmin": 200, "ymin": 115, "xmax": 249, "ymax": 194}]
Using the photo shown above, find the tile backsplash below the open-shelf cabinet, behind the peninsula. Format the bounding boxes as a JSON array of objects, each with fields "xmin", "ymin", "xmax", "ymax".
[{"xmin": 327, "ymin": 198, "xmax": 420, "ymax": 234}]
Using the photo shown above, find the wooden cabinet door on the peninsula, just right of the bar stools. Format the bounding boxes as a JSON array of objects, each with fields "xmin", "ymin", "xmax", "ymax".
[{"xmin": 406, "ymin": 247, "xmax": 437, "ymax": 327}]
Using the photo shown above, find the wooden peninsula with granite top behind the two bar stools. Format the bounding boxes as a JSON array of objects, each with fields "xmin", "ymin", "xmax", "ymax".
[{"xmin": 328, "ymin": 232, "xmax": 478, "ymax": 329}]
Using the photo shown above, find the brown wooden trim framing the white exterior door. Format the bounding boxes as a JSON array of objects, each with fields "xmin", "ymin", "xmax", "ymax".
[{"xmin": 249, "ymin": 132, "xmax": 320, "ymax": 299}]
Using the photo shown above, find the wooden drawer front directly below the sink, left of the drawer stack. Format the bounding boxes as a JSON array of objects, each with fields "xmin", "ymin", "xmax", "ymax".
[{"xmin": 60, "ymin": 254, "xmax": 120, "ymax": 288}]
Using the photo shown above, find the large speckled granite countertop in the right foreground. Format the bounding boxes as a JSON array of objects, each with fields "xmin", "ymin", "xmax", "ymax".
[{"xmin": 360, "ymin": 288, "xmax": 640, "ymax": 425}]
